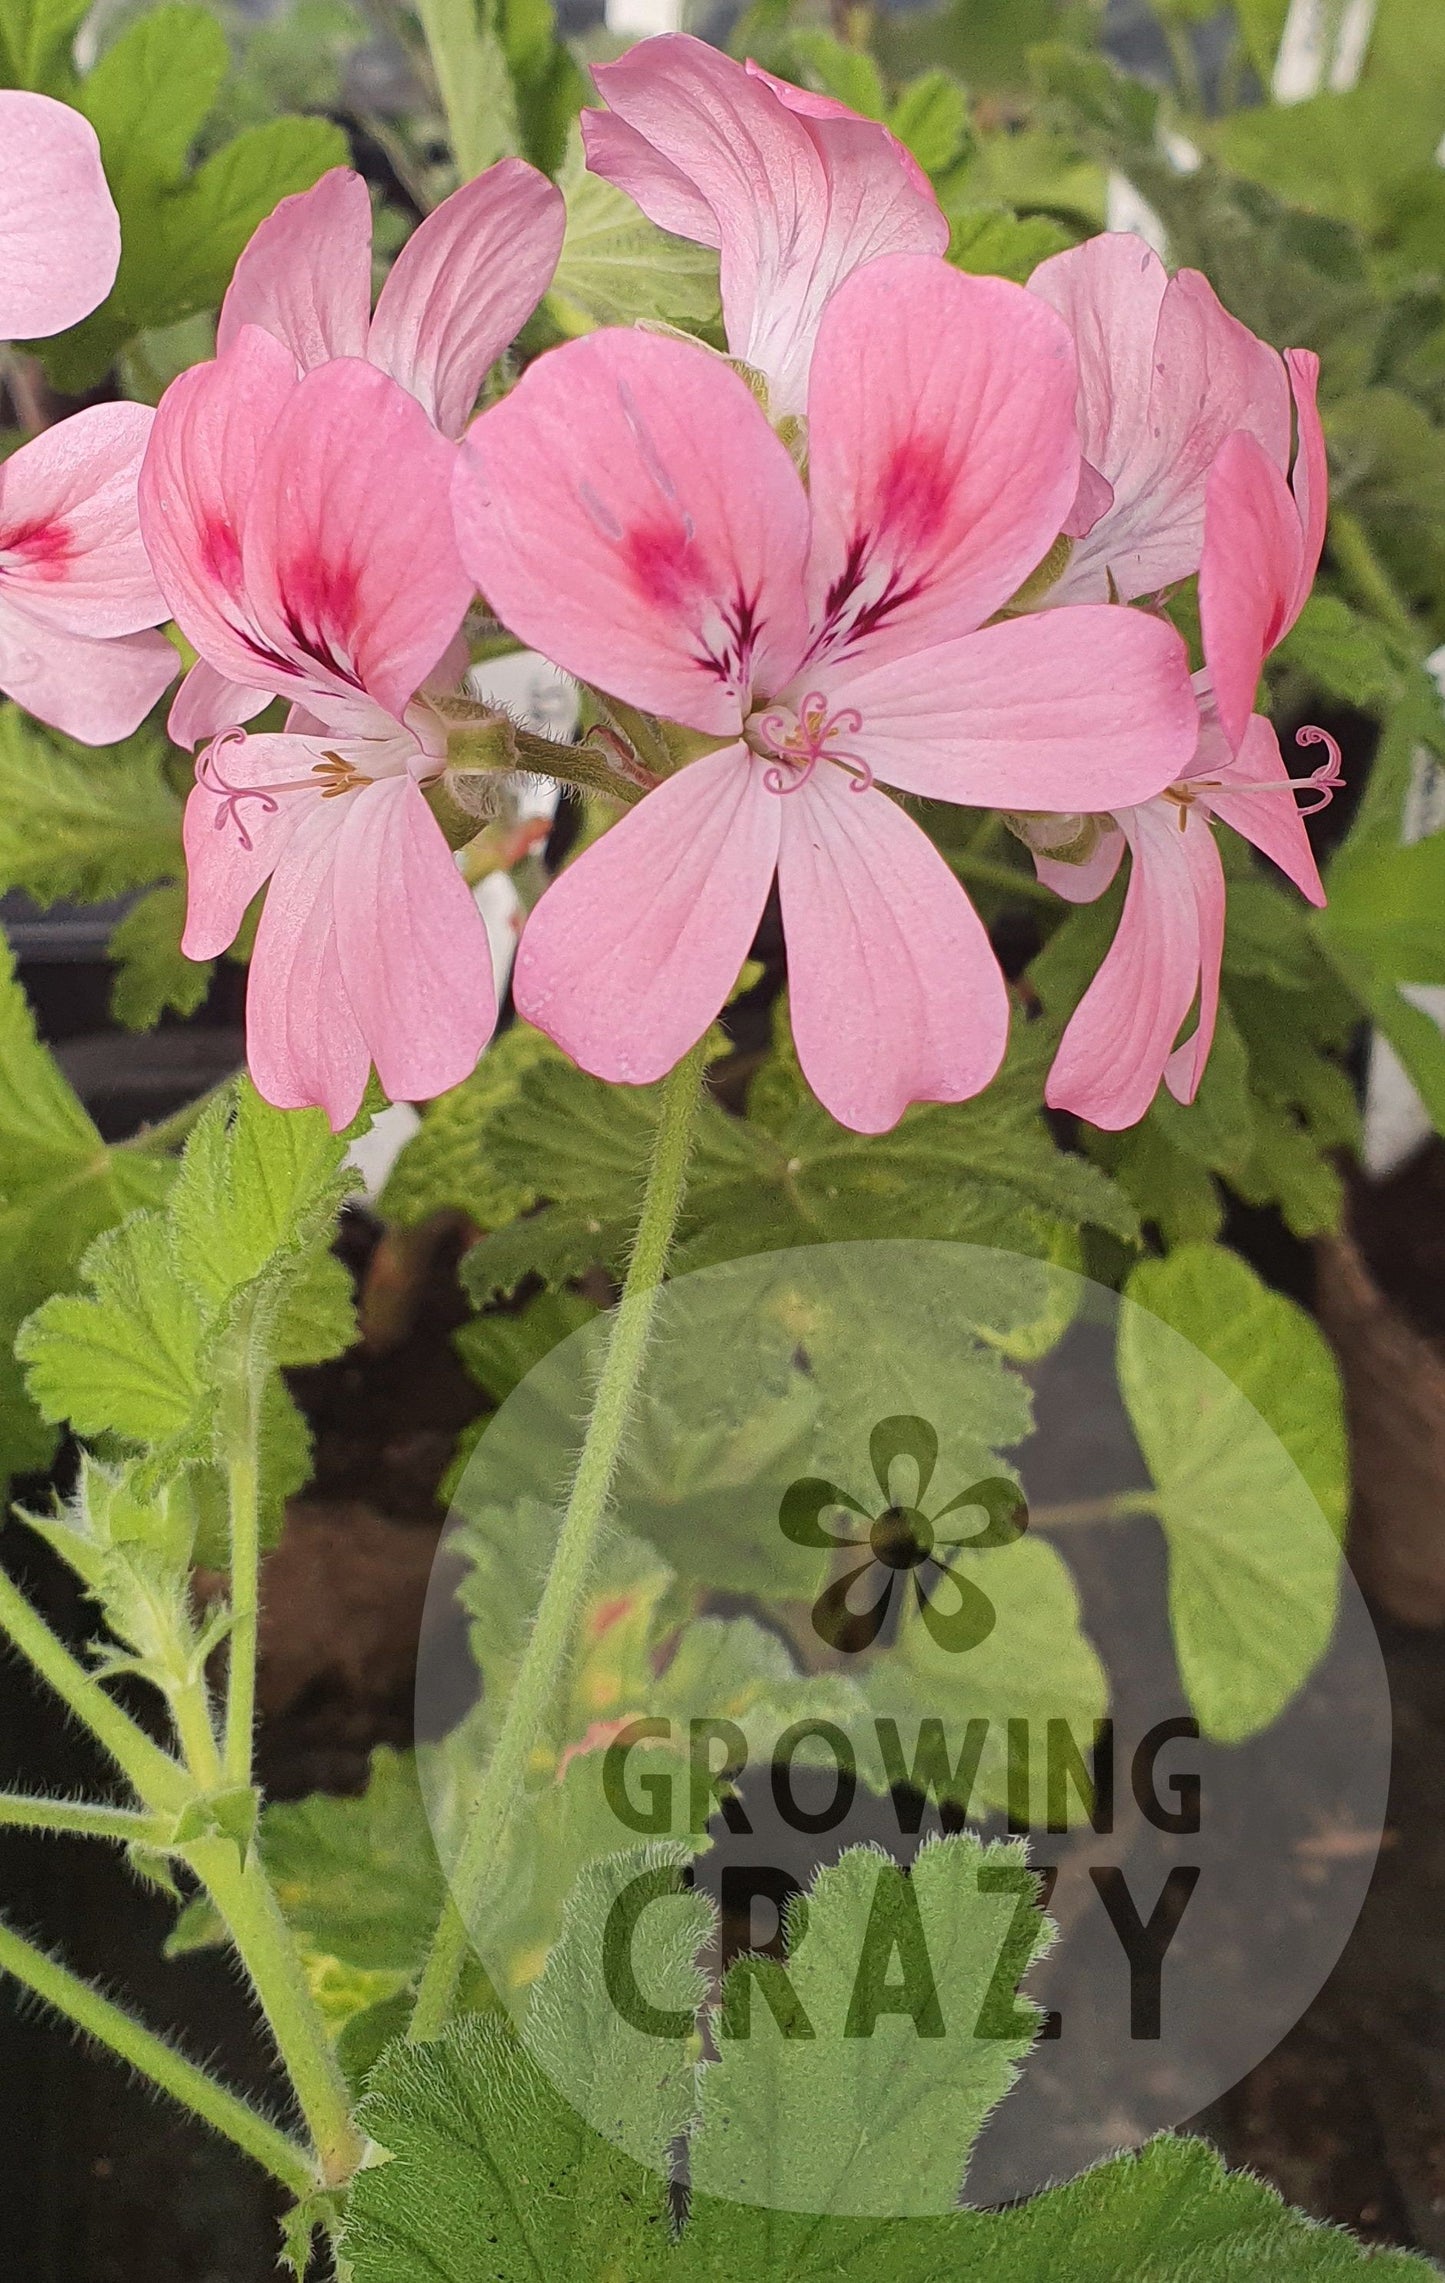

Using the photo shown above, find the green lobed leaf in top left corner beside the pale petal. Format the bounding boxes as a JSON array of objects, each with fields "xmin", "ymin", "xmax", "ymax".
[{"xmin": 37, "ymin": 5, "xmax": 347, "ymax": 393}]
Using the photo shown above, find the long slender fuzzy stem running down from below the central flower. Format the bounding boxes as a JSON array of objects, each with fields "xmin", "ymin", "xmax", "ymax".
[{"xmin": 409, "ymin": 1041, "xmax": 705, "ymax": 2041}]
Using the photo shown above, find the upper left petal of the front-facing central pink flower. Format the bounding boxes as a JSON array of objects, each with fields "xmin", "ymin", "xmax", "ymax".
[{"xmin": 454, "ymin": 328, "xmax": 808, "ymax": 735}]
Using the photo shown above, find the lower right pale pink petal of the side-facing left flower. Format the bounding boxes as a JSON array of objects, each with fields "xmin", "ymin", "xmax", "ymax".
[{"xmin": 331, "ymin": 776, "xmax": 498, "ymax": 1103}]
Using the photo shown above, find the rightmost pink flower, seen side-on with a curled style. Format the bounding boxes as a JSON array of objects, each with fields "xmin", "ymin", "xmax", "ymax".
[{"xmin": 1034, "ymin": 349, "xmax": 1340, "ymax": 1130}]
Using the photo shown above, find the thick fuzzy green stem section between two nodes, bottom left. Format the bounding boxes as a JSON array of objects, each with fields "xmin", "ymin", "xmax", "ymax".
[{"xmin": 185, "ymin": 1838, "xmax": 363, "ymax": 2185}]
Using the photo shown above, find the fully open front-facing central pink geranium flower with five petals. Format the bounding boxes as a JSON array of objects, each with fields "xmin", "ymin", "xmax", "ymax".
[{"xmin": 457, "ymin": 256, "xmax": 1194, "ymax": 1132}]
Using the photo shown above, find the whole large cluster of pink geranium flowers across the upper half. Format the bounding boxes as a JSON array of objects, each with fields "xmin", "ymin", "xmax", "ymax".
[{"xmin": 14, "ymin": 37, "xmax": 1338, "ymax": 1132}]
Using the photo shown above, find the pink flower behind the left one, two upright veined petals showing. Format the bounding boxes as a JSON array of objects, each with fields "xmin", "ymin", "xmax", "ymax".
[{"xmin": 169, "ymin": 158, "xmax": 566, "ymax": 747}]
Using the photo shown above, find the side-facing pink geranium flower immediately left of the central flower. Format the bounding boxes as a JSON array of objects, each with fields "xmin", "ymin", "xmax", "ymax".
[{"xmin": 139, "ymin": 326, "xmax": 495, "ymax": 1128}]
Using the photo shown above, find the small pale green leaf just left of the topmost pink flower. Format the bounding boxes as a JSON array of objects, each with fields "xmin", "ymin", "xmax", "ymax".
[{"xmin": 546, "ymin": 128, "xmax": 721, "ymax": 333}]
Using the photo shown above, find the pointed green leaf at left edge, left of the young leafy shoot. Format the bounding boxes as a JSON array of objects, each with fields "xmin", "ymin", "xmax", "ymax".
[{"xmin": 0, "ymin": 943, "xmax": 173, "ymax": 1477}]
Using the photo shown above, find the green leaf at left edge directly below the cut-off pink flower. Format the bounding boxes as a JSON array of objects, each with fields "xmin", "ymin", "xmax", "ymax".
[{"xmin": 0, "ymin": 705, "xmax": 185, "ymax": 904}]
